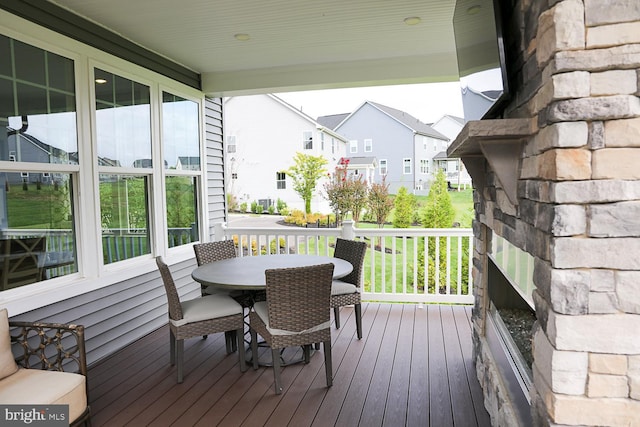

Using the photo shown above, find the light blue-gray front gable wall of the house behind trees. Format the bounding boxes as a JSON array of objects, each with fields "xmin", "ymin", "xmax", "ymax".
[{"xmin": 336, "ymin": 103, "xmax": 415, "ymax": 194}]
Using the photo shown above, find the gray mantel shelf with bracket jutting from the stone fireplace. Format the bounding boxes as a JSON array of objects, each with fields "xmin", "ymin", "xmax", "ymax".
[{"xmin": 447, "ymin": 119, "xmax": 535, "ymax": 206}]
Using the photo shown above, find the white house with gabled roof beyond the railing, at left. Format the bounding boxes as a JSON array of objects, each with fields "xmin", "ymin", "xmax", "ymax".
[{"xmin": 224, "ymin": 94, "xmax": 346, "ymax": 213}]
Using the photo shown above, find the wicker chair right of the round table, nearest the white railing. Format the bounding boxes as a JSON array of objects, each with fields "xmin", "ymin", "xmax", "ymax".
[{"xmin": 331, "ymin": 238, "xmax": 367, "ymax": 339}]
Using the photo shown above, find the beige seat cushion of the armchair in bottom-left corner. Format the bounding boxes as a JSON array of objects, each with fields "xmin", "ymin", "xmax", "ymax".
[{"xmin": 0, "ymin": 368, "xmax": 87, "ymax": 421}]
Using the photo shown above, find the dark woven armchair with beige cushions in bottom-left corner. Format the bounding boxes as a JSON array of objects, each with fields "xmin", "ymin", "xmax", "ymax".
[{"xmin": 0, "ymin": 309, "xmax": 91, "ymax": 426}]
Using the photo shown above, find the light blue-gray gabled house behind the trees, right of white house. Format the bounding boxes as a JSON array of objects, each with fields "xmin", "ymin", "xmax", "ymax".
[{"xmin": 335, "ymin": 101, "xmax": 449, "ymax": 194}]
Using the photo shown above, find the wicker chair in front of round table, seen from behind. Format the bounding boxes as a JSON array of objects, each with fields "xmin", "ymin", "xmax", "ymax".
[{"xmin": 249, "ymin": 263, "xmax": 334, "ymax": 394}]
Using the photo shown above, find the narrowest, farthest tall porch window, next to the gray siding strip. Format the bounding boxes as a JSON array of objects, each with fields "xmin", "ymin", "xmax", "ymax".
[{"xmin": 162, "ymin": 92, "xmax": 200, "ymax": 248}]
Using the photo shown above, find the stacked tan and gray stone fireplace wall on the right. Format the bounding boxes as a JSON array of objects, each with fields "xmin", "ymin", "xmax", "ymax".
[{"xmin": 473, "ymin": 0, "xmax": 640, "ymax": 426}]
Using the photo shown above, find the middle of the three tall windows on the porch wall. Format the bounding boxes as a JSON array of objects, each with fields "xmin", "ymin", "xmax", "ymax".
[{"xmin": 94, "ymin": 69, "xmax": 153, "ymax": 264}]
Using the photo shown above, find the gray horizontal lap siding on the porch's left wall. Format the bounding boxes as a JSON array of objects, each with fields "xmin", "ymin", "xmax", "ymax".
[{"xmin": 11, "ymin": 99, "xmax": 225, "ymax": 364}]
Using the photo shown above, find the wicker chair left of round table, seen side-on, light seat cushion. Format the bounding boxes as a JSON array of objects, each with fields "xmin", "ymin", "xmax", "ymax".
[{"xmin": 156, "ymin": 256, "xmax": 246, "ymax": 383}]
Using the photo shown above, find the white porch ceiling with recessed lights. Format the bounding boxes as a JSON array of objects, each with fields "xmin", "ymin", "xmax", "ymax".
[{"xmin": 51, "ymin": 0, "xmax": 458, "ymax": 96}]
